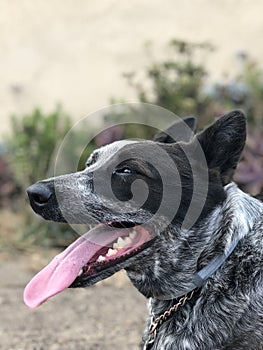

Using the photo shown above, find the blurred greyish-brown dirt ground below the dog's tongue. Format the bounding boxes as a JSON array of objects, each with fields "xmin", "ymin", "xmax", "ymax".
[{"xmin": 0, "ymin": 254, "xmax": 146, "ymax": 350}]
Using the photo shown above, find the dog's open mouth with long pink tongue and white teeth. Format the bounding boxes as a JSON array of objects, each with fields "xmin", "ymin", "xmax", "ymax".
[{"xmin": 24, "ymin": 222, "xmax": 154, "ymax": 308}]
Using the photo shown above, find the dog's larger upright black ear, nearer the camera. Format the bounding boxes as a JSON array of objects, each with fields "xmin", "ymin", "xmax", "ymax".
[{"xmin": 194, "ymin": 110, "xmax": 246, "ymax": 184}]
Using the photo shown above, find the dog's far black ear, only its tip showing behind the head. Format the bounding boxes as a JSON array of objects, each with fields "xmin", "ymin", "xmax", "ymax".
[{"xmin": 153, "ymin": 117, "xmax": 196, "ymax": 143}]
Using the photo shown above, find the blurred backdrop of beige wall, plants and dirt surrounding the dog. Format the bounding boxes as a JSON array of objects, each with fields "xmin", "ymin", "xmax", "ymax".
[{"xmin": 0, "ymin": 0, "xmax": 263, "ymax": 350}]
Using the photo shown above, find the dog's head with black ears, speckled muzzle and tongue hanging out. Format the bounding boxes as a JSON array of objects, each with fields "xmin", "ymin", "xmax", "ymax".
[{"xmin": 25, "ymin": 111, "xmax": 246, "ymax": 307}]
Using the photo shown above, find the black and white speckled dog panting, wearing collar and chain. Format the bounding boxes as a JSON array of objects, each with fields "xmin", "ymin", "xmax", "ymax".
[{"xmin": 24, "ymin": 110, "xmax": 263, "ymax": 350}]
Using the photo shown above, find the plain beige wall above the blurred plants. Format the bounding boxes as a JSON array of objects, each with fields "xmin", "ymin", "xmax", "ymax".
[{"xmin": 0, "ymin": 0, "xmax": 263, "ymax": 134}]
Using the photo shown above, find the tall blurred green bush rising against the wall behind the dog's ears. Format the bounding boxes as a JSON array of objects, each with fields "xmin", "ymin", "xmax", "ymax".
[{"xmin": 126, "ymin": 39, "xmax": 216, "ymax": 127}]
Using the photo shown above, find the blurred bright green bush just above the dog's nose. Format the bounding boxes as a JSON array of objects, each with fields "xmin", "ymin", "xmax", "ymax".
[{"xmin": 7, "ymin": 107, "xmax": 71, "ymax": 187}]
